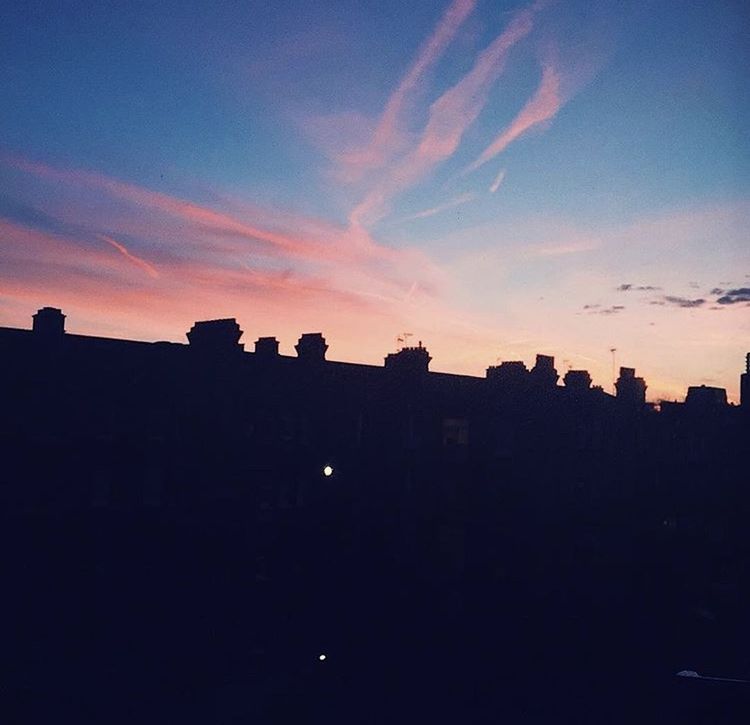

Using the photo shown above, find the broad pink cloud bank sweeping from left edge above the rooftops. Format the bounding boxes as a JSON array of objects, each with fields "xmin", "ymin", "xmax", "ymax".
[{"xmin": 0, "ymin": 153, "xmax": 446, "ymax": 340}]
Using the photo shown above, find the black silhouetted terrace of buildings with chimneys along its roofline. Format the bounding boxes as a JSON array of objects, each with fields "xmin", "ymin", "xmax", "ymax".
[{"xmin": 0, "ymin": 307, "xmax": 750, "ymax": 722}]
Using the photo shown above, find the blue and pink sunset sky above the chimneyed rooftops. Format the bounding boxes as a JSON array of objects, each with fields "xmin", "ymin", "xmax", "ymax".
[{"xmin": 0, "ymin": 0, "xmax": 750, "ymax": 402}]
